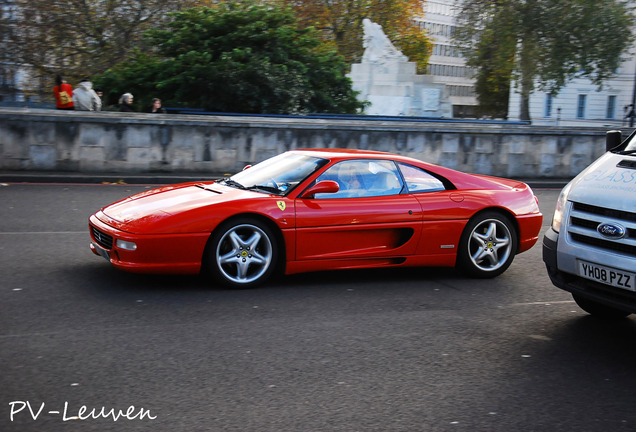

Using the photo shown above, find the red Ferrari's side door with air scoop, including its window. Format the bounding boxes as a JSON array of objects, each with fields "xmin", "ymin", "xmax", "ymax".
[{"xmin": 295, "ymin": 160, "xmax": 422, "ymax": 261}]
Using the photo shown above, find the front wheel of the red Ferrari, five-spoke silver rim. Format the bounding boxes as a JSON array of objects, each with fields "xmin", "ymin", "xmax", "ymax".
[{"xmin": 206, "ymin": 217, "xmax": 279, "ymax": 289}]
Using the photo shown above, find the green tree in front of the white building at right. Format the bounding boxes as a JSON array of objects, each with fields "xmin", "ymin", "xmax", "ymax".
[{"xmin": 456, "ymin": 0, "xmax": 633, "ymax": 120}]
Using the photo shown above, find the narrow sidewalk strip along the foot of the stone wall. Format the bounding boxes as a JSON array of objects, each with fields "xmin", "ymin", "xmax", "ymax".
[{"xmin": 0, "ymin": 171, "xmax": 571, "ymax": 189}]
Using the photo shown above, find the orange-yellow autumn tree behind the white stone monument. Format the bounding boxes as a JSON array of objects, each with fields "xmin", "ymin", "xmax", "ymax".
[{"xmin": 286, "ymin": 0, "xmax": 433, "ymax": 73}]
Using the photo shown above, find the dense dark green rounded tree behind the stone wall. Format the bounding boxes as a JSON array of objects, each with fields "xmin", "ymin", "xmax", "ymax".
[{"xmin": 97, "ymin": 0, "xmax": 364, "ymax": 114}]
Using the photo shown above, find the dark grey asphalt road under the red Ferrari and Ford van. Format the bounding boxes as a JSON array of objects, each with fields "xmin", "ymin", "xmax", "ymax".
[{"xmin": 0, "ymin": 184, "xmax": 636, "ymax": 432}]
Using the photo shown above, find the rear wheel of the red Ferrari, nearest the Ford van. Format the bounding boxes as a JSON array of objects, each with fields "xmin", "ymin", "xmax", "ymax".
[{"xmin": 457, "ymin": 211, "xmax": 519, "ymax": 278}]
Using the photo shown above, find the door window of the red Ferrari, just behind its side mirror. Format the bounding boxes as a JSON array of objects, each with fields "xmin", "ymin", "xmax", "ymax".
[{"xmin": 315, "ymin": 160, "xmax": 402, "ymax": 199}]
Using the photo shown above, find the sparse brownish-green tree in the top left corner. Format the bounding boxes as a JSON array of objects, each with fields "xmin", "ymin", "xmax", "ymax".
[{"xmin": 0, "ymin": 0, "xmax": 199, "ymax": 94}]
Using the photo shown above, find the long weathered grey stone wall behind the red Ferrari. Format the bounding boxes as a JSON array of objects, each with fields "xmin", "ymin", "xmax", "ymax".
[{"xmin": 0, "ymin": 108, "xmax": 629, "ymax": 178}]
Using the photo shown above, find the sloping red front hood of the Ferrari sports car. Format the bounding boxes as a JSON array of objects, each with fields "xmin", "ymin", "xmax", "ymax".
[{"xmin": 102, "ymin": 183, "xmax": 255, "ymax": 234}]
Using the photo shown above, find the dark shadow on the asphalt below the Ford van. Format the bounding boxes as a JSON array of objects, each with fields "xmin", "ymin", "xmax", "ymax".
[{"xmin": 510, "ymin": 315, "xmax": 636, "ymax": 416}]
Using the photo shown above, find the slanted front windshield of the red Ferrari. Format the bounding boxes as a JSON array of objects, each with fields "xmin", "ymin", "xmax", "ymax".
[{"xmin": 223, "ymin": 152, "xmax": 328, "ymax": 195}]
